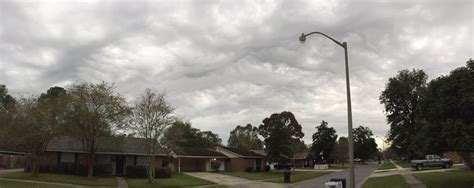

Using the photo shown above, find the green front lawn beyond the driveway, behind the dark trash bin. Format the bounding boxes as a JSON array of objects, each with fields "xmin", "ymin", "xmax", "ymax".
[{"xmin": 220, "ymin": 171, "xmax": 331, "ymax": 183}]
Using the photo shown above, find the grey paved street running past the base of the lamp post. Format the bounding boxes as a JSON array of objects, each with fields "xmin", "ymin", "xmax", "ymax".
[{"xmin": 290, "ymin": 164, "xmax": 378, "ymax": 188}]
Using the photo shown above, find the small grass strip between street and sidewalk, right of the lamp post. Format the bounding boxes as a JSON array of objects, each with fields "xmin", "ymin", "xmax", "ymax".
[{"xmin": 362, "ymin": 175, "xmax": 410, "ymax": 188}]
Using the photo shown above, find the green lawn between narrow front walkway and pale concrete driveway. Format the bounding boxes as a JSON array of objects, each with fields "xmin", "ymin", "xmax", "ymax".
[{"xmin": 127, "ymin": 174, "xmax": 215, "ymax": 188}]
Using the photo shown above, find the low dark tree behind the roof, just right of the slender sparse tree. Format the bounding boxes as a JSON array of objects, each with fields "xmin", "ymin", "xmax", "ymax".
[{"xmin": 161, "ymin": 120, "xmax": 222, "ymax": 150}]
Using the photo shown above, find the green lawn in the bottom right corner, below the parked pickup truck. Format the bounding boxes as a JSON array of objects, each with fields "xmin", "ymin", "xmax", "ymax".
[{"xmin": 413, "ymin": 170, "xmax": 474, "ymax": 188}]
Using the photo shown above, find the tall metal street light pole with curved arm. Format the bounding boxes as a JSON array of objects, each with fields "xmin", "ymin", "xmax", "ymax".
[{"xmin": 300, "ymin": 32, "xmax": 355, "ymax": 188}]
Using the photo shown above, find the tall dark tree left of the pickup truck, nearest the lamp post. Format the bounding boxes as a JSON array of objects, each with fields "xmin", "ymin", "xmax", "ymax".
[{"xmin": 380, "ymin": 70, "xmax": 428, "ymax": 158}]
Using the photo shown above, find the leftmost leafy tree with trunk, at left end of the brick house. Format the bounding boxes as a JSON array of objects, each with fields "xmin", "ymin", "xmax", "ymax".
[{"xmin": 8, "ymin": 87, "xmax": 67, "ymax": 177}]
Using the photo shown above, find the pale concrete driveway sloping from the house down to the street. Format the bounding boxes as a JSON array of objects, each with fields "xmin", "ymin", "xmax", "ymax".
[{"xmin": 184, "ymin": 172, "xmax": 286, "ymax": 188}]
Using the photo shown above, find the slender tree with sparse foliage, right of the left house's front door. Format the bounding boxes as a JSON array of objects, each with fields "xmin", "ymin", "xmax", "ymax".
[{"xmin": 131, "ymin": 89, "xmax": 174, "ymax": 183}]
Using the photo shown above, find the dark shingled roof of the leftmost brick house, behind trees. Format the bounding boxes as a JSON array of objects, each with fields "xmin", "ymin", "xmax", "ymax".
[{"xmin": 46, "ymin": 136, "xmax": 166, "ymax": 155}]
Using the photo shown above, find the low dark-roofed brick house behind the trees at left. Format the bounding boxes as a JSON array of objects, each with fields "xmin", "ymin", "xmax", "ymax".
[{"xmin": 41, "ymin": 137, "xmax": 167, "ymax": 176}]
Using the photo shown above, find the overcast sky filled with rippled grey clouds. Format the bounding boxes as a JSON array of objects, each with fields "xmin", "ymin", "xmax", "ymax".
[{"xmin": 0, "ymin": 0, "xmax": 474, "ymax": 147}]
